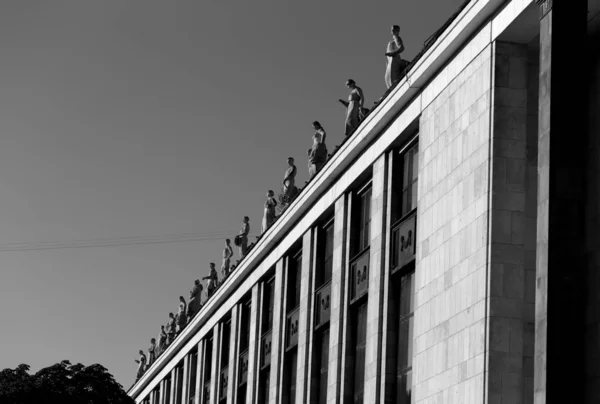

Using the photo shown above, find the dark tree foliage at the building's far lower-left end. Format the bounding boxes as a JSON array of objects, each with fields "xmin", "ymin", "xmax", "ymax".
[{"xmin": 0, "ymin": 361, "xmax": 135, "ymax": 404}]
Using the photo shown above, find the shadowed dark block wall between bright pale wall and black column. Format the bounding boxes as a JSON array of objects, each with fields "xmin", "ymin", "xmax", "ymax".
[{"xmin": 486, "ymin": 42, "xmax": 537, "ymax": 403}]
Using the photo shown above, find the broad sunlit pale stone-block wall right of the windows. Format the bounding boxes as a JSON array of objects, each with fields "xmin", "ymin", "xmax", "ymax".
[{"xmin": 411, "ymin": 45, "xmax": 492, "ymax": 404}]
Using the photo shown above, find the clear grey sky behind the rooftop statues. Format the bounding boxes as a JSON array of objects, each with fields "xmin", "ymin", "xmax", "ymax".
[{"xmin": 0, "ymin": 0, "xmax": 463, "ymax": 388}]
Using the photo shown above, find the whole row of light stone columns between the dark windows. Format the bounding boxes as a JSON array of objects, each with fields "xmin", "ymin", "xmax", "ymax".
[{"xmin": 142, "ymin": 150, "xmax": 392, "ymax": 404}]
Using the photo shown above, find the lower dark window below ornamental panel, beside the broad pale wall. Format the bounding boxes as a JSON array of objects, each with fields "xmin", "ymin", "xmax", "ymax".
[{"xmin": 396, "ymin": 271, "xmax": 415, "ymax": 404}]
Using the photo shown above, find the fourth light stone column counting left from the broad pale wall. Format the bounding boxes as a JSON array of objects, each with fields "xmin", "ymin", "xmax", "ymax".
[{"xmin": 269, "ymin": 258, "xmax": 286, "ymax": 404}]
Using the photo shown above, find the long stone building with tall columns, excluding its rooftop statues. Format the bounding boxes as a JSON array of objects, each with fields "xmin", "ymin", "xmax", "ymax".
[{"xmin": 129, "ymin": 0, "xmax": 600, "ymax": 404}]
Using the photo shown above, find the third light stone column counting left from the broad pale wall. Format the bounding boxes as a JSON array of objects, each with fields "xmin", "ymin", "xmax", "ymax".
[{"xmin": 296, "ymin": 230, "xmax": 314, "ymax": 403}]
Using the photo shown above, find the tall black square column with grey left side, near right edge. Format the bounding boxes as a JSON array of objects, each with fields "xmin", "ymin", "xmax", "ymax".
[{"xmin": 534, "ymin": 0, "xmax": 588, "ymax": 404}]
